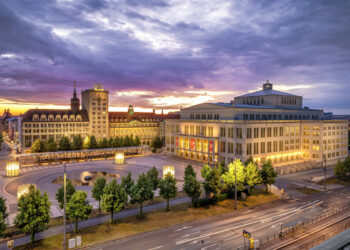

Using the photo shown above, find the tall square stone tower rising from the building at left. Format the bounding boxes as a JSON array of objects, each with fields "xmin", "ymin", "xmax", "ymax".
[{"xmin": 81, "ymin": 83, "xmax": 108, "ymax": 139}]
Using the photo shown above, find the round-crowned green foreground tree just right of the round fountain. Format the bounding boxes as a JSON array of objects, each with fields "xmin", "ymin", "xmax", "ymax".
[{"xmin": 102, "ymin": 179, "xmax": 128, "ymax": 224}]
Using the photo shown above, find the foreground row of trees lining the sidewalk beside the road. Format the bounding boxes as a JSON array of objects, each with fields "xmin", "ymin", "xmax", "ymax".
[{"xmin": 0, "ymin": 160, "xmax": 277, "ymax": 242}]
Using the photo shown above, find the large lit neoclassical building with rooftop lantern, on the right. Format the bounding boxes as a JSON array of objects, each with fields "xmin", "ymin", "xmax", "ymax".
[{"xmin": 165, "ymin": 82, "xmax": 348, "ymax": 172}]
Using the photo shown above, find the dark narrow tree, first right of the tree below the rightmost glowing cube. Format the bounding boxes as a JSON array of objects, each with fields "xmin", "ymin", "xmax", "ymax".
[{"xmin": 183, "ymin": 165, "xmax": 202, "ymax": 206}]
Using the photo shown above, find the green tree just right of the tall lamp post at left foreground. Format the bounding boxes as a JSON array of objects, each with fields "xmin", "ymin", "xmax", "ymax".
[{"xmin": 67, "ymin": 190, "xmax": 92, "ymax": 232}]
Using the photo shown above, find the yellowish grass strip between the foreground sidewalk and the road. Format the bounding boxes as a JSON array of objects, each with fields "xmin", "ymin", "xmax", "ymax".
[{"xmin": 15, "ymin": 190, "xmax": 279, "ymax": 249}]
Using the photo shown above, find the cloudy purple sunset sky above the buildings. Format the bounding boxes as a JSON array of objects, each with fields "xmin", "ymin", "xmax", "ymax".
[{"xmin": 0, "ymin": 0, "xmax": 350, "ymax": 114}]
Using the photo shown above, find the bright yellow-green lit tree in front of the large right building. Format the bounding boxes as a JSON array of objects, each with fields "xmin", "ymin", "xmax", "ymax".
[{"xmin": 221, "ymin": 159, "xmax": 244, "ymax": 191}]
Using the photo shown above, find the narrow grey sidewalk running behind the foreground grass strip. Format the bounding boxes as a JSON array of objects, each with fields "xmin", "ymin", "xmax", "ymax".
[{"xmin": 0, "ymin": 197, "xmax": 191, "ymax": 249}]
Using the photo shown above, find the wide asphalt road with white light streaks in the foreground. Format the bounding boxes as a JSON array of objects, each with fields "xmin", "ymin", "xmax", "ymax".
[{"xmin": 82, "ymin": 187, "xmax": 350, "ymax": 250}]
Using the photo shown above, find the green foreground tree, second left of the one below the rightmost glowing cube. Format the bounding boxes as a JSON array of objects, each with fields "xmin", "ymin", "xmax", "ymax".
[{"xmin": 131, "ymin": 173, "xmax": 154, "ymax": 217}]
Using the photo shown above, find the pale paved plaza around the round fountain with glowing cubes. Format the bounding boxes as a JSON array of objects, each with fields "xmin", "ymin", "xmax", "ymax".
[{"xmin": 0, "ymin": 154, "xmax": 201, "ymax": 225}]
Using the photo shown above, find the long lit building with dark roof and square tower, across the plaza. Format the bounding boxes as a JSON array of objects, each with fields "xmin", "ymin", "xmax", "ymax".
[{"xmin": 19, "ymin": 84, "xmax": 180, "ymax": 151}]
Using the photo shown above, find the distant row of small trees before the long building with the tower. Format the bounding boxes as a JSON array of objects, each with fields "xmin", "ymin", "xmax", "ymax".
[{"xmin": 31, "ymin": 135, "xmax": 141, "ymax": 153}]
